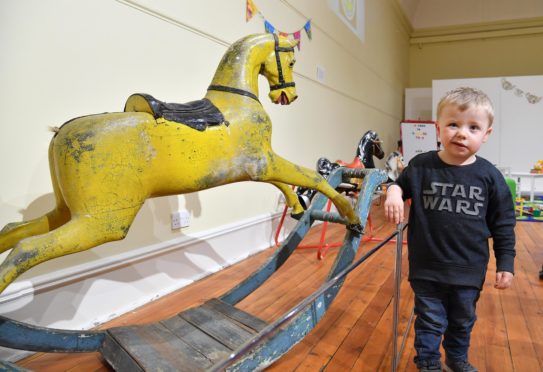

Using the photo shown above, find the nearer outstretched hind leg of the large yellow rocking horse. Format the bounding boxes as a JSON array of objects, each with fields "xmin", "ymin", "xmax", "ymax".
[{"xmin": 0, "ymin": 205, "xmax": 141, "ymax": 293}]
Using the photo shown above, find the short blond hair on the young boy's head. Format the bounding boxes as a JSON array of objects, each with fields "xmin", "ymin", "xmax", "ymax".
[{"xmin": 437, "ymin": 87, "xmax": 494, "ymax": 128}]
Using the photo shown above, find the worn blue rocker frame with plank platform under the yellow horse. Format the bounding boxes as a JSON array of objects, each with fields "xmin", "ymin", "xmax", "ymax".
[{"xmin": 0, "ymin": 168, "xmax": 387, "ymax": 371}]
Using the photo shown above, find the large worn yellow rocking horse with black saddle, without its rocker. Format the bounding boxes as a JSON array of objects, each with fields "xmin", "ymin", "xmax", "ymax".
[{"xmin": 0, "ymin": 34, "xmax": 360, "ymax": 292}]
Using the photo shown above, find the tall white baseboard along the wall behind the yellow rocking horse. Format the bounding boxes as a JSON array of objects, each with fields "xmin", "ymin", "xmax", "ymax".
[{"xmin": 0, "ymin": 213, "xmax": 293, "ymax": 361}]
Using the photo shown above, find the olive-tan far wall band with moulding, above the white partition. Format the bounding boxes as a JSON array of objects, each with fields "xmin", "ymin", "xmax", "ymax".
[{"xmin": 409, "ymin": 18, "xmax": 543, "ymax": 88}]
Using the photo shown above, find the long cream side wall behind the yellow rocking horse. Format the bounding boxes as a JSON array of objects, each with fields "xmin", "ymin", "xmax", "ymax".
[{"xmin": 0, "ymin": 0, "xmax": 409, "ymax": 275}]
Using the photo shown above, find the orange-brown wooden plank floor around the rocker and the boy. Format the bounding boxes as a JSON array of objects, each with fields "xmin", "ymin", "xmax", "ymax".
[{"xmin": 18, "ymin": 208, "xmax": 543, "ymax": 372}]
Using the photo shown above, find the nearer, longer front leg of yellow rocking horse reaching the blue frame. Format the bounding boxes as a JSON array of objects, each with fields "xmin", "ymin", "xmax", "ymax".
[{"xmin": 260, "ymin": 155, "xmax": 361, "ymax": 231}]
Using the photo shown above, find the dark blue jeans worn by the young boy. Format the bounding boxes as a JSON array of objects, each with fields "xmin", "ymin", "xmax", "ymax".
[{"xmin": 411, "ymin": 280, "xmax": 481, "ymax": 368}]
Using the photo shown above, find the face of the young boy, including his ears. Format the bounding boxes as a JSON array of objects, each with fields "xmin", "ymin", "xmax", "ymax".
[{"xmin": 437, "ymin": 105, "xmax": 492, "ymax": 165}]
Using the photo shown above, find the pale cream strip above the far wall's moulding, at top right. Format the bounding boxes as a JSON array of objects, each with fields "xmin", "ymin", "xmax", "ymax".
[{"xmin": 397, "ymin": 0, "xmax": 543, "ymax": 30}]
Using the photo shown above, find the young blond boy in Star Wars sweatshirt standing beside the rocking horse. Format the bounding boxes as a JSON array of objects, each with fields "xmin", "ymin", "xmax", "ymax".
[{"xmin": 384, "ymin": 88, "xmax": 515, "ymax": 372}]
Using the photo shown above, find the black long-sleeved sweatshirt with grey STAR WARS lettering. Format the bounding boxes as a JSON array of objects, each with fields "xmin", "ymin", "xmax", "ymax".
[{"xmin": 395, "ymin": 151, "xmax": 515, "ymax": 288}]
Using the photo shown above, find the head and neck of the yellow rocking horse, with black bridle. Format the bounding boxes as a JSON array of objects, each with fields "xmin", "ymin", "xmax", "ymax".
[{"xmin": 208, "ymin": 34, "xmax": 298, "ymax": 105}]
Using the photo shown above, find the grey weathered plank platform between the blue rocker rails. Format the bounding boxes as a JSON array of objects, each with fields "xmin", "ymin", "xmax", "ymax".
[{"xmin": 101, "ymin": 299, "xmax": 267, "ymax": 371}]
